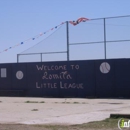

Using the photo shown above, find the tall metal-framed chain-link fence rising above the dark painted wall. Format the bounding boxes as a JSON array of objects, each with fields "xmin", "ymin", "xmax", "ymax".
[{"xmin": 17, "ymin": 15, "xmax": 130, "ymax": 62}]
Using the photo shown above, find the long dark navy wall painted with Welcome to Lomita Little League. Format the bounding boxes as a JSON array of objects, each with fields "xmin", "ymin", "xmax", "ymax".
[{"xmin": 0, "ymin": 59, "xmax": 130, "ymax": 98}]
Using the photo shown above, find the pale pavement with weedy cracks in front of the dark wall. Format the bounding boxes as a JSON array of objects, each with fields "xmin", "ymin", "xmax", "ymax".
[{"xmin": 0, "ymin": 97, "xmax": 130, "ymax": 125}]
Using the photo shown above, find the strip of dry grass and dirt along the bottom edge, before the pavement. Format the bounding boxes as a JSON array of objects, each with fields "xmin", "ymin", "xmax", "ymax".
[{"xmin": 0, "ymin": 118, "xmax": 129, "ymax": 130}]
